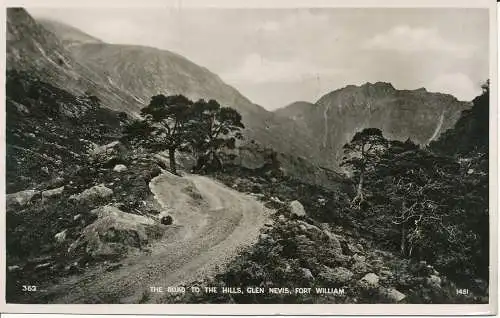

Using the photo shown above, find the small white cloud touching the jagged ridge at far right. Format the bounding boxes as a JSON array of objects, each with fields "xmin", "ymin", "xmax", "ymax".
[{"xmin": 427, "ymin": 73, "xmax": 481, "ymax": 101}]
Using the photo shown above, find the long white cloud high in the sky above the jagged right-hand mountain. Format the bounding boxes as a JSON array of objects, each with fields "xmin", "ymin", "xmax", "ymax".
[{"xmin": 364, "ymin": 25, "xmax": 475, "ymax": 58}]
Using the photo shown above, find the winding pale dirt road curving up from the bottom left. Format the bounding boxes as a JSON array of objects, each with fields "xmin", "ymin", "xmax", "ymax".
[{"xmin": 41, "ymin": 173, "xmax": 269, "ymax": 303}]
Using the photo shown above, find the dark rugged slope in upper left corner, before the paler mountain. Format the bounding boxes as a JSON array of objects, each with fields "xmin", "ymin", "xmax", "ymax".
[{"xmin": 6, "ymin": 8, "xmax": 138, "ymax": 112}]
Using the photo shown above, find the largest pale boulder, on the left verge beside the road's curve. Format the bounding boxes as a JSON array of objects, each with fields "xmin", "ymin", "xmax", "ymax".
[{"xmin": 68, "ymin": 205, "xmax": 164, "ymax": 258}]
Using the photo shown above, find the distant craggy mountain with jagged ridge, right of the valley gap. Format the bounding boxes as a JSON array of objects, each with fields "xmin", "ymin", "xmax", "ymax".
[{"xmin": 276, "ymin": 82, "xmax": 471, "ymax": 164}]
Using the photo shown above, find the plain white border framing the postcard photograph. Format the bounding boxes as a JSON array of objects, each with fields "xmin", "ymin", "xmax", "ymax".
[{"xmin": 0, "ymin": 0, "xmax": 499, "ymax": 315}]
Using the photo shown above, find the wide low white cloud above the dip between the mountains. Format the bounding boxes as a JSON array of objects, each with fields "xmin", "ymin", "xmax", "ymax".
[{"xmin": 221, "ymin": 53, "xmax": 342, "ymax": 84}]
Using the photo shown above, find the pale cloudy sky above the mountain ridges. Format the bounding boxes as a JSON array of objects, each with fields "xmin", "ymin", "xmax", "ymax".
[{"xmin": 28, "ymin": 8, "xmax": 489, "ymax": 110}]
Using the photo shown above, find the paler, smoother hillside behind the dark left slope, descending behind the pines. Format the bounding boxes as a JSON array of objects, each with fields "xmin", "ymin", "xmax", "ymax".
[{"xmin": 33, "ymin": 13, "xmax": 314, "ymax": 165}]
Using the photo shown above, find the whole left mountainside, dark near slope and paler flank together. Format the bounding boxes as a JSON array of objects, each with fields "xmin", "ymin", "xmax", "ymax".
[{"xmin": 18, "ymin": 9, "xmax": 320, "ymax": 166}]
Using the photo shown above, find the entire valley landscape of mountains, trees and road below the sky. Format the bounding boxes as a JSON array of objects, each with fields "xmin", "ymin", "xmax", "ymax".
[{"xmin": 5, "ymin": 8, "xmax": 490, "ymax": 304}]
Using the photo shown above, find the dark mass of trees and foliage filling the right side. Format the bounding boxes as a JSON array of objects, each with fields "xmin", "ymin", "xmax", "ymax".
[{"xmin": 345, "ymin": 85, "xmax": 489, "ymax": 281}]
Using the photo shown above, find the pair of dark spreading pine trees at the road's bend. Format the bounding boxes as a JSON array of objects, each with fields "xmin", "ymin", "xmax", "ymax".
[{"xmin": 125, "ymin": 94, "xmax": 244, "ymax": 173}]
